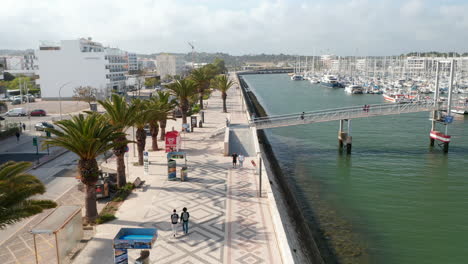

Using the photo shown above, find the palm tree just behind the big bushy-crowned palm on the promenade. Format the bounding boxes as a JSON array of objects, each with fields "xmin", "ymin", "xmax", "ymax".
[{"xmin": 98, "ymin": 94, "xmax": 137, "ymax": 187}]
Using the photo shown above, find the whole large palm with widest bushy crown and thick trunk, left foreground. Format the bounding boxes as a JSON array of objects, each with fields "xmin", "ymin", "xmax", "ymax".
[{"xmin": 43, "ymin": 113, "xmax": 127, "ymax": 222}]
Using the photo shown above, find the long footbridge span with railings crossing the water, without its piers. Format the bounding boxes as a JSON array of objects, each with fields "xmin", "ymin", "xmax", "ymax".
[{"xmin": 250, "ymin": 100, "xmax": 444, "ymax": 129}]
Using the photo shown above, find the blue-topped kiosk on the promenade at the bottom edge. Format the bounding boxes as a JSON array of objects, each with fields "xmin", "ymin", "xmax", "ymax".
[{"xmin": 114, "ymin": 228, "xmax": 158, "ymax": 264}]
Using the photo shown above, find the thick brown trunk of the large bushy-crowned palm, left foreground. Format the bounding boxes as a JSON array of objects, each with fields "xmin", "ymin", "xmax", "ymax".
[{"xmin": 78, "ymin": 159, "xmax": 99, "ymax": 223}]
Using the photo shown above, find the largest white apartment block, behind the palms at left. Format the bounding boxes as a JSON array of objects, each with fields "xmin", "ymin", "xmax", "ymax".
[{"xmin": 36, "ymin": 38, "xmax": 128, "ymax": 100}]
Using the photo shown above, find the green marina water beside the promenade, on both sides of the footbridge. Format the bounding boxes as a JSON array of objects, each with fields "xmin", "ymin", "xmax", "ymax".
[{"xmin": 244, "ymin": 74, "xmax": 468, "ymax": 264}]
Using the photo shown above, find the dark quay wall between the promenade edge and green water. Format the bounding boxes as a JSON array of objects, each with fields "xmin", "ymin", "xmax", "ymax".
[{"xmin": 236, "ymin": 73, "xmax": 338, "ymax": 264}]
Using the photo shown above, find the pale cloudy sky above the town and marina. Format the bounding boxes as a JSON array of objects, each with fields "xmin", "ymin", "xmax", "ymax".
[{"xmin": 0, "ymin": 0, "xmax": 468, "ymax": 56}]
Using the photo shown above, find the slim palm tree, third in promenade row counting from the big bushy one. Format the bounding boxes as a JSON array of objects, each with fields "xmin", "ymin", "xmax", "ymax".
[{"xmin": 132, "ymin": 98, "xmax": 149, "ymax": 165}]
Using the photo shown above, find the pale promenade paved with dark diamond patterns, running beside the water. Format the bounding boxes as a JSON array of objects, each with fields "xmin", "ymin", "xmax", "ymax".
[{"xmin": 73, "ymin": 84, "xmax": 282, "ymax": 264}]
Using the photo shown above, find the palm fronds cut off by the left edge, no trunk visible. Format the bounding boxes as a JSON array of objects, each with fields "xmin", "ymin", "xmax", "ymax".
[{"xmin": 0, "ymin": 161, "xmax": 57, "ymax": 229}]
